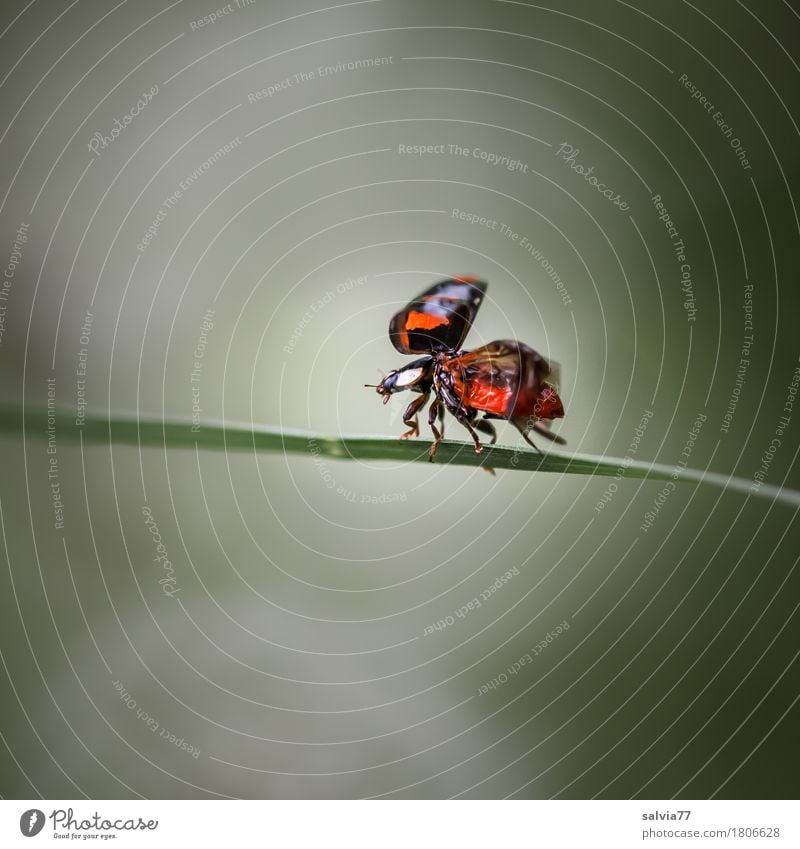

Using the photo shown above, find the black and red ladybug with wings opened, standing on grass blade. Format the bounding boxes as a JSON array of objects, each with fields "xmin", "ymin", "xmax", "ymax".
[{"xmin": 365, "ymin": 277, "xmax": 566, "ymax": 462}]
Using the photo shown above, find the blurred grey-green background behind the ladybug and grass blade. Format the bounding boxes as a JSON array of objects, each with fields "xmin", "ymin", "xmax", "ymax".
[{"xmin": 0, "ymin": 0, "xmax": 800, "ymax": 798}]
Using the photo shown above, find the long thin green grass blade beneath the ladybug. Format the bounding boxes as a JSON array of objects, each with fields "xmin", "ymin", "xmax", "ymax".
[{"xmin": 0, "ymin": 406, "xmax": 800, "ymax": 506}]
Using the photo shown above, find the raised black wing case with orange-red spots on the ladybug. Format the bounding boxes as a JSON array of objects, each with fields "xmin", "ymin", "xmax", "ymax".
[{"xmin": 389, "ymin": 277, "xmax": 488, "ymax": 354}]
